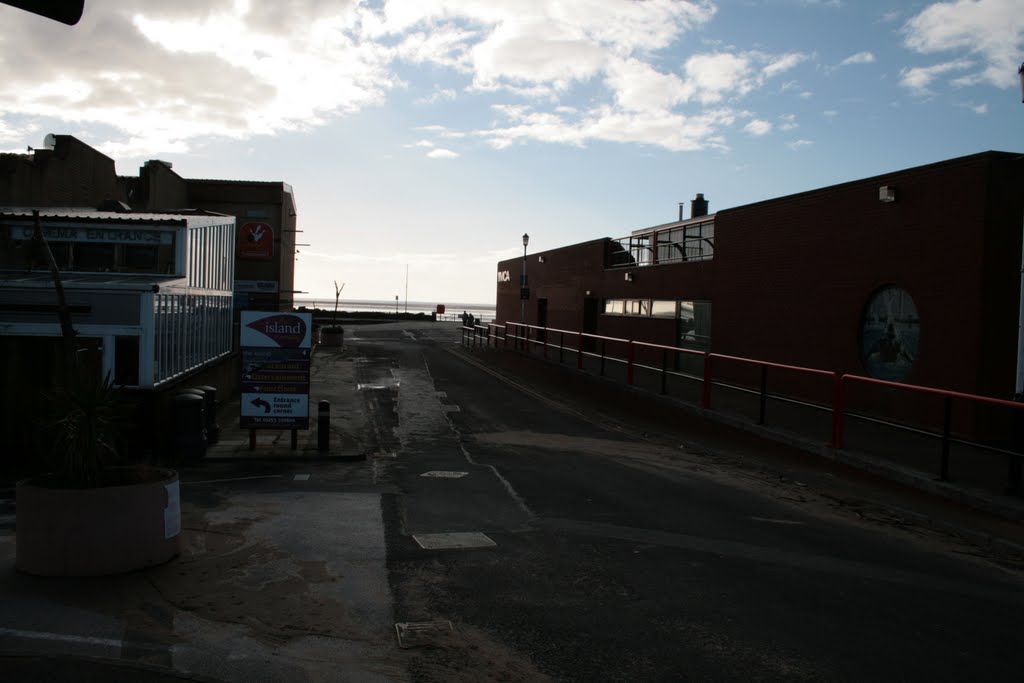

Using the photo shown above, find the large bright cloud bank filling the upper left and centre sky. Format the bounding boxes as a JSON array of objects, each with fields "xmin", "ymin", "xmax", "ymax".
[{"xmin": 0, "ymin": 0, "xmax": 809, "ymax": 158}]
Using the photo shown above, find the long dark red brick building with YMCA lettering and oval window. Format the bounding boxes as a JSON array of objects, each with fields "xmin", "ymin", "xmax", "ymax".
[{"xmin": 497, "ymin": 152, "xmax": 1024, "ymax": 400}]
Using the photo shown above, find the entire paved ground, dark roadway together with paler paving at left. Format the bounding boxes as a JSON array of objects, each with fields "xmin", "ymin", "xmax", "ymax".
[{"xmin": 0, "ymin": 324, "xmax": 1024, "ymax": 683}]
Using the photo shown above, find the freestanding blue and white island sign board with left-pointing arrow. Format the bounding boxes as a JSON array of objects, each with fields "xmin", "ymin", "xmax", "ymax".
[{"xmin": 240, "ymin": 310, "xmax": 312, "ymax": 429}]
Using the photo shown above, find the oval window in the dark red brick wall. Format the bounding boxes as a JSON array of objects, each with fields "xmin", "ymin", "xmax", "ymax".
[{"xmin": 860, "ymin": 286, "xmax": 921, "ymax": 382}]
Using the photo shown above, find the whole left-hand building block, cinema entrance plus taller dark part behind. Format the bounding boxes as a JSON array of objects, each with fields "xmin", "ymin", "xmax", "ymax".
[{"xmin": 0, "ymin": 135, "xmax": 296, "ymax": 465}]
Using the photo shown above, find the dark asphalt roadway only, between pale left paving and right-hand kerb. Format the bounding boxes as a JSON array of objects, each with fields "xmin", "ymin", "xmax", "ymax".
[{"xmin": 352, "ymin": 329, "xmax": 1024, "ymax": 681}]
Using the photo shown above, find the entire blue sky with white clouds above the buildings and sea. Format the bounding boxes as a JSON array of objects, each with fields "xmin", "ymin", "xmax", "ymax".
[{"xmin": 0, "ymin": 0, "xmax": 1024, "ymax": 304}]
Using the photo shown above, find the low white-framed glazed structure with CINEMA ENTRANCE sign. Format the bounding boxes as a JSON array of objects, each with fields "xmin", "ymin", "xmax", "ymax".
[{"xmin": 0, "ymin": 208, "xmax": 236, "ymax": 389}]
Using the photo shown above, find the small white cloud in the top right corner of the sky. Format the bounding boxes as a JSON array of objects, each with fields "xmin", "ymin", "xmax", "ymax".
[{"xmin": 902, "ymin": 0, "xmax": 1024, "ymax": 92}]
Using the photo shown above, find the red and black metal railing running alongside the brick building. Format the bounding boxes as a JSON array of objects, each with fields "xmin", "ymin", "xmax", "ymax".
[{"xmin": 463, "ymin": 322, "xmax": 1024, "ymax": 494}]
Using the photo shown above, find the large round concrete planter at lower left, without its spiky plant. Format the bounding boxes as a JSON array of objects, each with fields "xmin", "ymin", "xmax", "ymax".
[{"xmin": 14, "ymin": 470, "xmax": 181, "ymax": 577}]
